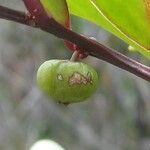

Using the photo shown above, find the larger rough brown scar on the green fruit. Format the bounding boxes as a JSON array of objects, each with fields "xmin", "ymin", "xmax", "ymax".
[{"xmin": 69, "ymin": 72, "xmax": 93, "ymax": 86}]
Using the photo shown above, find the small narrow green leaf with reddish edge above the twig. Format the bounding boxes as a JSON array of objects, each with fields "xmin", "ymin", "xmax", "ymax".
[{"xmin": 40, "ymin": 0, "xmax": 70, "ymax": 27}]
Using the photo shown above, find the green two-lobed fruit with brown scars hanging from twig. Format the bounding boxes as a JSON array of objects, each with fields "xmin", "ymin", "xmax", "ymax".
[{"xmin": 37, "ymin": 60, "xmax": 99, "ymax": 104}]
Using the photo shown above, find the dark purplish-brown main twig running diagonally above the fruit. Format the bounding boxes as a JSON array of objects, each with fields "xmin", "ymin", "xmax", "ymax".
[{"xmin": 0, "ymin": 6, "xmax": 150, "ymax": 81}]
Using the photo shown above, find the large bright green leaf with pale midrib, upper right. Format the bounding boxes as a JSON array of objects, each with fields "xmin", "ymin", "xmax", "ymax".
[{"xmin": 67, "ymin": 0, "xmax": 150, "ymax": 59}]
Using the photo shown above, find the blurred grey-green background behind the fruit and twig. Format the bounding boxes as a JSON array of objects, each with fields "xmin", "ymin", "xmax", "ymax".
[{"xmin": 0, "ymin": 0, "xmax": 150, "ymax": 150}]
